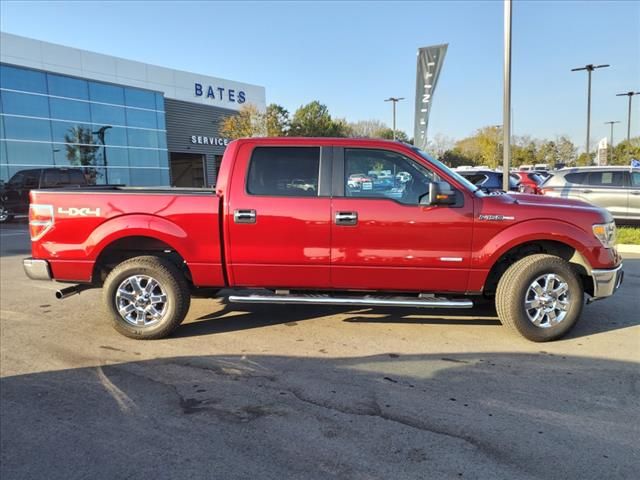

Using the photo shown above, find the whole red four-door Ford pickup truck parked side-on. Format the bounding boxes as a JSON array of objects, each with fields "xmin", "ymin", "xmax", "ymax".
[{"xmin": 24, "ymin": 138, "xmax": 623, "ymax": 341}]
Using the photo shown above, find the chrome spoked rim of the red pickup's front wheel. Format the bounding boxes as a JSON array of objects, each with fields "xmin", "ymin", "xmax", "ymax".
[{"xmin": 524, "ymin": 273, "xmax": 571, "ymax": 328}]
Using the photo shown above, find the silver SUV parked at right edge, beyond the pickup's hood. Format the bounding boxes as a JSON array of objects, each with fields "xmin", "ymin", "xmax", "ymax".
[{"xmin": 540, "ymin": 166, "xmax": 640, "ymax": 221}]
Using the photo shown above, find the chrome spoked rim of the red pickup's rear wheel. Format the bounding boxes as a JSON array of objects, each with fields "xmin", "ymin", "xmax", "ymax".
[{"xmin": 116, "ymin": 275, "xmax": 167, "ymax": 327}]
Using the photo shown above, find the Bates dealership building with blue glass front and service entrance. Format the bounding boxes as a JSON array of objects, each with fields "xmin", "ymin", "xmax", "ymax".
[{"xmin": 0, "ymin": 33, "xmax": 265, "ymax": 187}]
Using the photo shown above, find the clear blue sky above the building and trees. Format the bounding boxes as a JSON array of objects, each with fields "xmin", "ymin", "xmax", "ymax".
[{"xmin": 0, "ymin": 0, "xmax": 640, "ymax": 147}]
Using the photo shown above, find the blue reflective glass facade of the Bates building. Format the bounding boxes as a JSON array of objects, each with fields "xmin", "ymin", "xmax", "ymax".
[{"xmin": 0, "ymin": 64, "xmax": 169, "ymax": 186}]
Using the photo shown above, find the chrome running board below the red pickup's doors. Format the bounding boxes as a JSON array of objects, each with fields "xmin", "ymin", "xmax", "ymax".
[{"xmin": 229, "ymin": 294, "xmax": 473, "ymax": 308}]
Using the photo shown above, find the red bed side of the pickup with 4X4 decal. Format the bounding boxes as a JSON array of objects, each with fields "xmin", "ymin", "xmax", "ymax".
[{"xmin": 31, "ymin": 185, "xmax": 225, "ymax": 286}]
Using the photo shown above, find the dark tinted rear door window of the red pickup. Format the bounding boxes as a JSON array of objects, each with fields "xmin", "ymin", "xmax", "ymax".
[{"xmin": 247, "ymin": 147, "xmax": 320, "ymax": 197}]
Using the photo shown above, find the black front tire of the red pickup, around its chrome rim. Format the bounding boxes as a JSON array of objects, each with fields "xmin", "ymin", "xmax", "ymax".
[{"xmin": 496, "ymin": 254, "xmax": 584, "ymax": 342}]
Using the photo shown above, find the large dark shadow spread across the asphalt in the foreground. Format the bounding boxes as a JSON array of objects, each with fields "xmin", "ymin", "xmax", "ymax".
[{"xmin": 0, "ymin": 350, "xmax": 640, "ymax": 480}]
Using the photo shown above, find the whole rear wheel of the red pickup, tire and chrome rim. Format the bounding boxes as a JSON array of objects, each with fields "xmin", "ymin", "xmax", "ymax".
[{"xmin": 103, "ymin": 256, "xmax": 191, "ymax": 340}]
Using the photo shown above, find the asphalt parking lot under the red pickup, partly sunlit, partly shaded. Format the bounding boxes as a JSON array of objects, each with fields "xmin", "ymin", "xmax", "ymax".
[{"xmin": 0, "ymin": 224, "xmax": 640, "ymax": 480}]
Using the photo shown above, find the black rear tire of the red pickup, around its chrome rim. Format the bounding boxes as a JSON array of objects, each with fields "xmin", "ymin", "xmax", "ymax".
[{"xmin": 103, "ymin": 256, "xmax": 191, "ymax": 340}]
